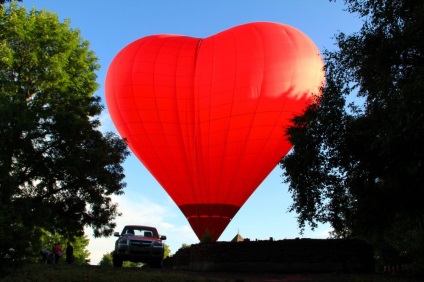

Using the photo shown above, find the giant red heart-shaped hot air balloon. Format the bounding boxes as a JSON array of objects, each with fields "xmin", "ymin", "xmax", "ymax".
[{"xmin": 105, "ymin": 22, "xmax": 324, "ymax": 241}]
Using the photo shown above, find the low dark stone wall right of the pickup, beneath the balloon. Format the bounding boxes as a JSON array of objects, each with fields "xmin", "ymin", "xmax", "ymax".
[{"xmin": 164, "ymin": 239, "xmax": 374, "ymax": 273}]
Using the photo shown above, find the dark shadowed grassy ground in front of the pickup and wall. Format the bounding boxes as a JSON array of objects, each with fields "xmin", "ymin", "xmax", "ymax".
[{"xmin": 0, "ymin": 264, "xmax": 422, "ymax": 282}]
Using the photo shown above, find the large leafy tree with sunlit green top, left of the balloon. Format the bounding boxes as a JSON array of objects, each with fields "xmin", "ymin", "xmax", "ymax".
[{"xmin": 0, "ymin": 3, "xmax": 129, "ymax": 265}]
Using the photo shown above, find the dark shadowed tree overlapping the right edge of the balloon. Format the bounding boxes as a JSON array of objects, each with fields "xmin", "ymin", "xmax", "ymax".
[{"xmin": 280, "ymin": 0, "xmax": 424, "ymax": 264}]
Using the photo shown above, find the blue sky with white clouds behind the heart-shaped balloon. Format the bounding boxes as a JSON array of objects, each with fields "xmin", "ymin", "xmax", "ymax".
[{"xmin": 21, "ymin": 0, "xmax": 361, "ymax": 264}]
